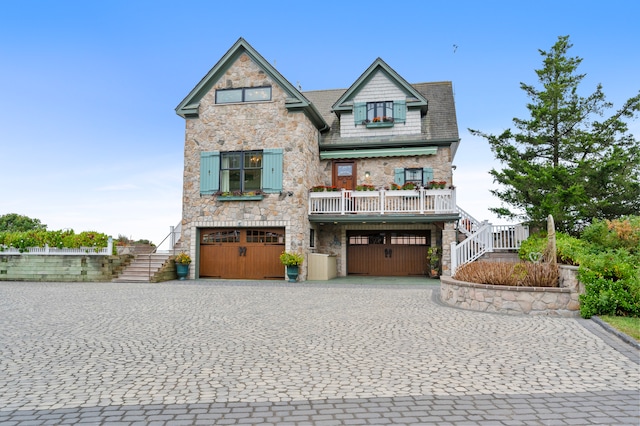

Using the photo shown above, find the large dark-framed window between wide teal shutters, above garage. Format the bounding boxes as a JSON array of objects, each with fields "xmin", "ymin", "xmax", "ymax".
[{"xmin": 220, "ymin": 151, "xmax": 262, "ymax": 192}]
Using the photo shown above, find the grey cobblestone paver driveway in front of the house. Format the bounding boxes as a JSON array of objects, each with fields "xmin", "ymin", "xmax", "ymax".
[{"xmin": 0, "ymin": 281, "xmax": 640, "ymax": 425}]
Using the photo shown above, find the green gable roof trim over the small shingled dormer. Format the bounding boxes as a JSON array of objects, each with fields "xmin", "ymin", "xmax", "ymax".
[{"xmin": 331, "ymin": 58, "xmax": 428, "ymax": 116}]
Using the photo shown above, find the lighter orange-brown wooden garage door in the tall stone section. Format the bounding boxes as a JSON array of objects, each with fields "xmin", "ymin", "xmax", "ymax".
[{"xmin": 200, "ymin": 228, "xmax": 285, "ymax": 280}]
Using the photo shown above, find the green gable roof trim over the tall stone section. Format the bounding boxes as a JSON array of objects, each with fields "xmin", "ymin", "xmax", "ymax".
[{"xmin": 176, "ymin": 37, "xmax": 329, "ymax": 131}]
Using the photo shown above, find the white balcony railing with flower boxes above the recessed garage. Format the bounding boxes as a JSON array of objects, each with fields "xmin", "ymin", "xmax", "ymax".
[{"xmin": 309, "ymin": 188, "xmax": 457, "ymax": 215}]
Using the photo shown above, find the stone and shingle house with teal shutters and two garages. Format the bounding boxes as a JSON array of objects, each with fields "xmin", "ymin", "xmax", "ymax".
[{"xmin": 176, "ymin": 38, "xmax": 459, "ymax": 279}]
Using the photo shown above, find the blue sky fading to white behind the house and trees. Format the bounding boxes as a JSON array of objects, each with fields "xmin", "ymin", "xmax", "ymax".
[{"xmin": 0, "ymin": 0, "xmax": 640, "ymax": 243}]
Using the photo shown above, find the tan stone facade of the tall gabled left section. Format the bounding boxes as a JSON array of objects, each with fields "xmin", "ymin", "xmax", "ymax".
[{"xmin": 182, "ymin": 54, "xmax": 323, "ymax": 280}]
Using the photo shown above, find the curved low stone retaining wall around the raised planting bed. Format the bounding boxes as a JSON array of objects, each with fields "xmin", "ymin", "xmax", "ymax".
[{"xmin": 440, "ymin": 265, "xmax": 584, "ymax": 317}]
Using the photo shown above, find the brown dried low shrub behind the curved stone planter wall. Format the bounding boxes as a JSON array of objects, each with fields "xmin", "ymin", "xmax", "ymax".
[{"xmin": 453, "ymin": 262, "xmax": 559, "ymax": 287}]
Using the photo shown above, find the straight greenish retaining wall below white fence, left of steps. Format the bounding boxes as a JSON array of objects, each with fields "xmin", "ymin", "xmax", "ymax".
[{"xmin": 0, "ymin": 255, "xmax": 133, "ymax": 281}]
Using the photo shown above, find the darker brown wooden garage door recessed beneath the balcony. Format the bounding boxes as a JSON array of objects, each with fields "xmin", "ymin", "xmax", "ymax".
[{"xmin": 347, "ymin": 230, "xmax": 431, "ymax": 276}]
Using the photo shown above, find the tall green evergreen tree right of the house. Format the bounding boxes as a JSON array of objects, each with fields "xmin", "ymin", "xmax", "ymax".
[{"xmin": 469, "ymin": 36, "xmax": 640, "ymax": 234}]
